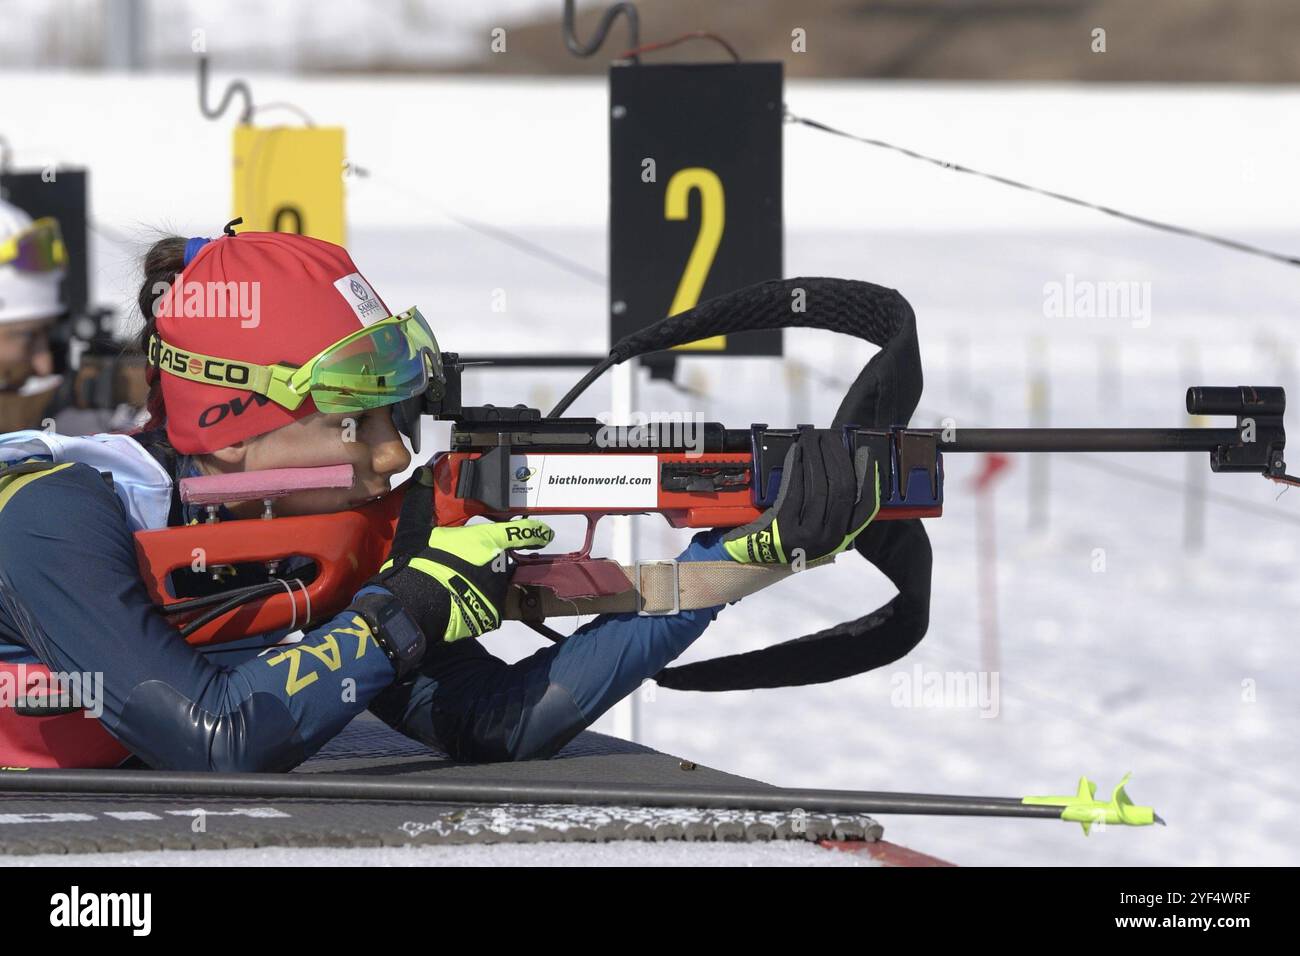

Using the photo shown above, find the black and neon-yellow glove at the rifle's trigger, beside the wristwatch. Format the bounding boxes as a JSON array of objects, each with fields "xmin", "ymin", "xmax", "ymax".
[{"xmin": 369, "ymin": 468, "xmax": 555, "ymax": 643}]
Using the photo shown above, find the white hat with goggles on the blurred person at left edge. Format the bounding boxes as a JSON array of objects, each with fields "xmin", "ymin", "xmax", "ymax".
[{"xmin": 0, "ymin": 199, "xmax": 66, "ymax": 325}]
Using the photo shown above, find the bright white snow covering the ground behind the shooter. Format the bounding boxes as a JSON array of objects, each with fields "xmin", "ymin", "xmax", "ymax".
[{"xmin": 5, "ymin": 74, "xmax": 1300, "ymax": 865}]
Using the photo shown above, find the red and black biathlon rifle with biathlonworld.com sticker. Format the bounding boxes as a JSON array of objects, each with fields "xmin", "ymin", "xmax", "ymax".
[{"xmin": 137, "ymin": 278, "xmax": 1295, "ymax": 689}]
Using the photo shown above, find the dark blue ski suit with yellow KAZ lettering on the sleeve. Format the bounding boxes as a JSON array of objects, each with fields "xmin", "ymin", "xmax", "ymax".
[{"xmin": 0, "ymin": 437, "xmax": 725, "ymax": 771}]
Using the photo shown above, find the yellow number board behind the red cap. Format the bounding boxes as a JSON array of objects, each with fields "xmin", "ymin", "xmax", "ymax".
[{"xmin": 233, "ymin": 126, "xmax": 347, "ymax": 246}]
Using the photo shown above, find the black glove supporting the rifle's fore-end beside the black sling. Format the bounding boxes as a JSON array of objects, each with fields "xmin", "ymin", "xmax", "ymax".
[{"xmin": 723, "ymin": 429, "xmax": 880, "ymax": 564}]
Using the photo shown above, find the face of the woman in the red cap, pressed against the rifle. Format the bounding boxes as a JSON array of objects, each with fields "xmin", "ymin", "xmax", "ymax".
[{"xmin": 199, "ymin": 407, "xmax": 411, "ymax": 516}]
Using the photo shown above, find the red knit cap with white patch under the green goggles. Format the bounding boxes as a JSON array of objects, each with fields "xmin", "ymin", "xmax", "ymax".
[{"xmin": 157, "ymin": 233, "xmax": 391, "ymax": 454}]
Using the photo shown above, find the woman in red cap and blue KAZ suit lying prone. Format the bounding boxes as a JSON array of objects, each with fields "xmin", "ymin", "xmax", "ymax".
[{"xmin": 0, "ymin": 233, "xmax": 879, "ymax": 771}]
